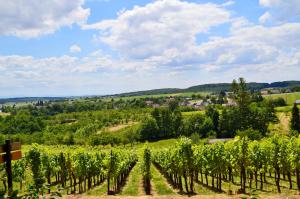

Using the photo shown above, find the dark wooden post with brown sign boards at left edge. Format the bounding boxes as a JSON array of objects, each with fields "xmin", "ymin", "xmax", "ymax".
[{"xmin": 0, "ymin": 140, "xmax": 22, "ymax": 196}]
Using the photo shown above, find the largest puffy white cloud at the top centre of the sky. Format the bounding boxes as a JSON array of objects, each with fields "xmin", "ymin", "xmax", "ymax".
[{"xmin": 83, "ymin": 0, "xmax": 230, "ymax": 59}]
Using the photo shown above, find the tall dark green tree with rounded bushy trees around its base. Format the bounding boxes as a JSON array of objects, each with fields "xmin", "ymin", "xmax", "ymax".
[{"xmin": 219, "ymin": 78, "xmax": 276, "ymax": 137}]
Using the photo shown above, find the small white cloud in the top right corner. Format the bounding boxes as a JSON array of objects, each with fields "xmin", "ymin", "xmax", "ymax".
[{"xmin": 259, "ymin": 0, "xmax": 300, "ymax": 23}]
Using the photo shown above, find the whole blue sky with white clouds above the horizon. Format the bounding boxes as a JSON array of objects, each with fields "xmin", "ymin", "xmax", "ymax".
[{"xmin": 0, "ymin": 0, "xmax": 300, "ymax": 97}]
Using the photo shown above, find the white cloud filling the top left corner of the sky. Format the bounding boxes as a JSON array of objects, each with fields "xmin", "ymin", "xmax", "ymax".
[{"xmin": 0, "ymin": 0, "xmax": 90, "ymax": 38}]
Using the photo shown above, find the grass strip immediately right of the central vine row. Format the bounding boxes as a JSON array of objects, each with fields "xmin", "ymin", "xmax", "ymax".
[{"xmin": 151, "ymin": 165, "xmax": 175, "ymax": 195}]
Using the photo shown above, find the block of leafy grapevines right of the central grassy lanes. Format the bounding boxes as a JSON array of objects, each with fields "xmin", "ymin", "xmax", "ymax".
[{"xmin": 153, "ymin": 136, "xmax": 300, "ymax": 193}]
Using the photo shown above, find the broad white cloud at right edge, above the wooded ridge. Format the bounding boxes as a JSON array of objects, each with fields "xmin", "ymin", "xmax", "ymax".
[{"xmin": 190, "ymin": 23, "xmax": 300, "ymax": 76}]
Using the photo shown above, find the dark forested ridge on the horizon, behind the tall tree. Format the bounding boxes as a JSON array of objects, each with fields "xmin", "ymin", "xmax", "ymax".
[{"xmin": 113, "ymin": 81, "xmax": 300, "ymax": 97}]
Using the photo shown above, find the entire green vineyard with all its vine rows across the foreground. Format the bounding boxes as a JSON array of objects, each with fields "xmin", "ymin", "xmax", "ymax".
[{"xmin": 0, "ymin": 136, "xmax": 300, "ymax": 197}]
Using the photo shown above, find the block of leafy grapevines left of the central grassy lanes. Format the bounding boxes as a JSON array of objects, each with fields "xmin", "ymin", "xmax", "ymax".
[{"xmin": 0, "ymin": 145, "xmax": 137, "ymax": 197}]
